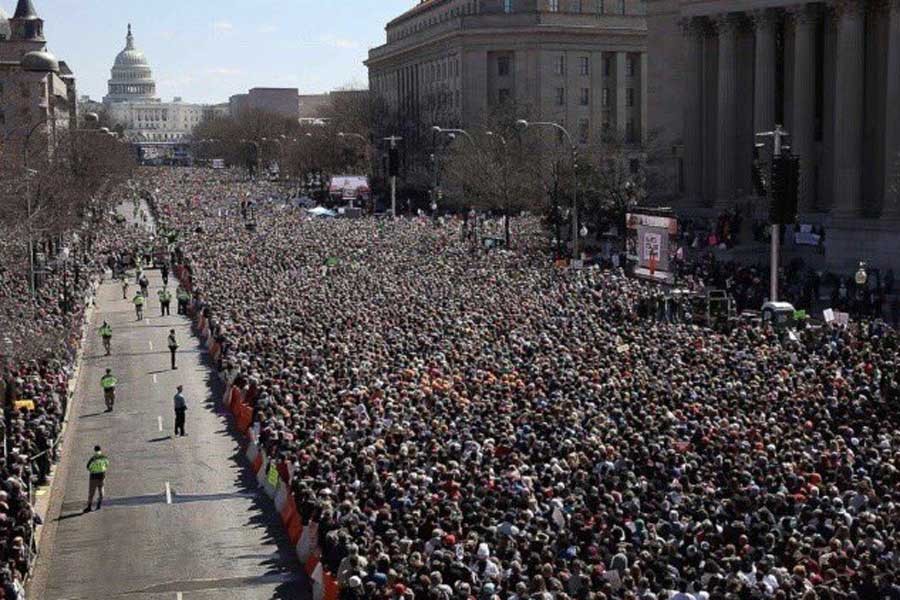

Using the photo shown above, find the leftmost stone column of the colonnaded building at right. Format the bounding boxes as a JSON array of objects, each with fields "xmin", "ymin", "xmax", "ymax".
[{"xmin": 681, "ymin": 17, "xmax": 707, "ymax": 205}]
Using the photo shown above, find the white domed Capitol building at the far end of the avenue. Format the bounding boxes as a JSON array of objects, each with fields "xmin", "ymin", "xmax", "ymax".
[{"xmin": 103, "ymin": 25, "xmax": 228, "ymax": 143}]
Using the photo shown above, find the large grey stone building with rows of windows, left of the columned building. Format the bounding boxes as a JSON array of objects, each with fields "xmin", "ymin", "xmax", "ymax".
[{"xmin": 366, "ymin": 0, "xmax": 648, "ymax": 143}]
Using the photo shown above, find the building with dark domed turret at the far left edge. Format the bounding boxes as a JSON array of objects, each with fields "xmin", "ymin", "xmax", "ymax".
[{"xmin": 0, "ymin": 0, "xmax": 77, "ymax": 144}]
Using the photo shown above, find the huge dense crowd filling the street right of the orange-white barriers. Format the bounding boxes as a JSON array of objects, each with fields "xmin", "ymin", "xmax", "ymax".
[{"xmin": 126, "ymin": 170, "xmax": 900, "ymax": 600}]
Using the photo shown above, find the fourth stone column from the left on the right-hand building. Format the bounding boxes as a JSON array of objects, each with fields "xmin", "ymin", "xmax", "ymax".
[{"xmin": 789, "ymin": 5, "xmax": 819, "ymax": 211}]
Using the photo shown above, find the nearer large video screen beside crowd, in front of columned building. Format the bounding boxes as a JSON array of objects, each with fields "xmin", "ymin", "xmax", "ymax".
[{"xmin": 625, "ymin": 213, "xmax": 678, "ymax": 284}]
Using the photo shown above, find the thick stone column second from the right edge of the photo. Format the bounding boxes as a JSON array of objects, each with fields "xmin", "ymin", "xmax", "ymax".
[{"xmin": 832, "ymin": 0, "xmax": 865, "ymax": 217}]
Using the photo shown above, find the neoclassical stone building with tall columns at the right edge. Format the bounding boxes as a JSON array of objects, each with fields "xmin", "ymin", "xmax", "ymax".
[{"xmin": 647, "ymin": 0, "xmax": 900, "ymax": 270}]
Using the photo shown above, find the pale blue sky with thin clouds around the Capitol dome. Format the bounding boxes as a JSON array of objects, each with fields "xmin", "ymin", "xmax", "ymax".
[{"xmin": 20, "ymin": 0, "xmax": 418, "ymax": 102}]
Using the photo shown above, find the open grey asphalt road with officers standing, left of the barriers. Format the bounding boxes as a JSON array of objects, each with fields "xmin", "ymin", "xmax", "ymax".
[{"xmin": 28, "ymin": 262, "xmax": 310, "ymax": 600}]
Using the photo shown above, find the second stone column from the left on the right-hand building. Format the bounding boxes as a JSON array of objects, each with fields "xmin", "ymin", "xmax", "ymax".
[{"xmin": 715, "ymin": 14, "xmax": 738, "ymax": 205}]
